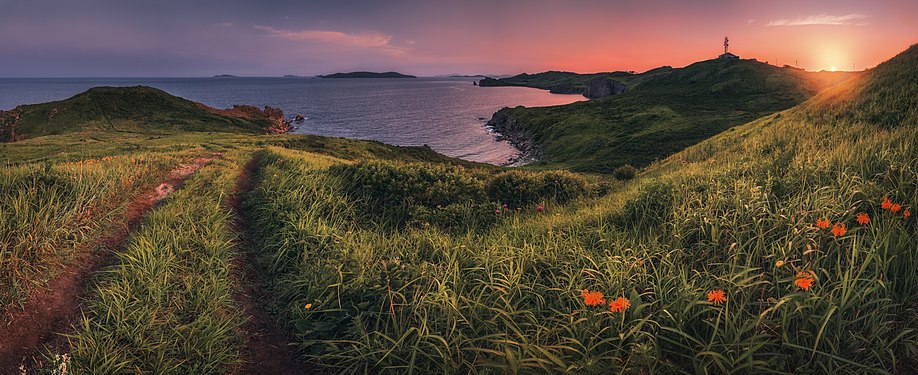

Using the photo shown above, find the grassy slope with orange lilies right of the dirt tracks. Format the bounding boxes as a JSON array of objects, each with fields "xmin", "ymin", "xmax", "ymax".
[{"xmin": 244, "ymin": 47, "xmax": 918, "ymax": 373}]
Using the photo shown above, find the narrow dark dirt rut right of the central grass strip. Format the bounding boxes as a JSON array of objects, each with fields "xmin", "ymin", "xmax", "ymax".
[{"xmin": 229, "ymin": 154, "xmax": 311, "ymax": 374}]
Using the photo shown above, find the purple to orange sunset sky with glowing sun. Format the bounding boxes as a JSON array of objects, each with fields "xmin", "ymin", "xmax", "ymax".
[{"xmin": 0, "ymin": 0, "xmax": 918, "ymax": 77}]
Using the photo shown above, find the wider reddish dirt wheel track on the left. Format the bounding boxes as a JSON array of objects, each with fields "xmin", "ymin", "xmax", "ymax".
[{"xmin": 0, "ymin": 154, "xmax": 220, "ymax": 374}]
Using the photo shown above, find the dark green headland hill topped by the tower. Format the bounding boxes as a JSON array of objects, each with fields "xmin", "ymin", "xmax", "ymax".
[{"xmin": 491, "ymin": 60, "xmax": 849, "ymax": 173}]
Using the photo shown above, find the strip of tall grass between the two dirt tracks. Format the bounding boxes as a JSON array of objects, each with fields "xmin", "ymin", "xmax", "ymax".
[{"xmin": 71, "ymin": 153, "xmax": 243, "ymax": 374}]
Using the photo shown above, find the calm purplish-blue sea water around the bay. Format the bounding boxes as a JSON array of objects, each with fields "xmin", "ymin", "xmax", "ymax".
[{"xmin": 0, "ymin": 78, "xmax": 584, "ymax": 164}]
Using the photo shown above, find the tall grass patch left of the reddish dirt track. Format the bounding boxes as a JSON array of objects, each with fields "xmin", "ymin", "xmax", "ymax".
[{"xmin": 0, "ymin": 153, "xmax": 177, "ymax": 307}]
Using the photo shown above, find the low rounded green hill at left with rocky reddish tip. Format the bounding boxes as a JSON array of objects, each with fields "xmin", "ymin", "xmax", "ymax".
[{"xmin": 0, "ymin": 86, "xmax": 283, "ymax": 141}]
